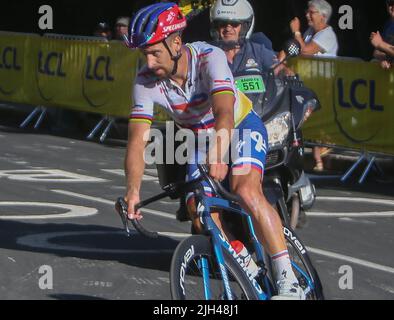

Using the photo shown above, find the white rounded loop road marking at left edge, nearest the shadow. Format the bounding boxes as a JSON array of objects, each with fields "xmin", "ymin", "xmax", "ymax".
[{"xmin": 0, "ymin": 201, "xmax": 98, "ymax": 220}]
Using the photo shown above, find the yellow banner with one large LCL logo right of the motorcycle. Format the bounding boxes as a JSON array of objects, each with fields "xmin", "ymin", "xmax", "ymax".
[{"xmin": 290, "ymin": 58, "xmax": 394, "ymax": 155}]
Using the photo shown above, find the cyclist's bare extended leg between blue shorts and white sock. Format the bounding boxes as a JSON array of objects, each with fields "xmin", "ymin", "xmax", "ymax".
[{"xmin": 231, "ymin": 167, "xmax": 287, "ymax": 255}]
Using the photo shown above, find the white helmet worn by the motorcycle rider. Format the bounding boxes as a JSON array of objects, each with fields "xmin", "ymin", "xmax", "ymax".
[{"xmin": 210, "ymin": 0, "xmax": 255, "ymax": 42}]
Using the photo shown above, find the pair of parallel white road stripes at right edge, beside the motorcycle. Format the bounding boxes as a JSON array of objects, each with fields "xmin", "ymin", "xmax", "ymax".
[{"xmin": 306, "ymin": 197, "xmax": 394, "ymax": 218}]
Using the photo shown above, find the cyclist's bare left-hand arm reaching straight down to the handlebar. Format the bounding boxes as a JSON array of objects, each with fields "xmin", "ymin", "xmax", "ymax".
[{"xmin": 125, "ymin": 123, "xmax": 150, "ymax": 219}]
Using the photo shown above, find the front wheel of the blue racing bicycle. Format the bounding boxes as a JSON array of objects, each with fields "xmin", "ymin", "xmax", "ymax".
[{"xmin": 170, "ymin": 235, "xmax": 258, "ymax": 300}]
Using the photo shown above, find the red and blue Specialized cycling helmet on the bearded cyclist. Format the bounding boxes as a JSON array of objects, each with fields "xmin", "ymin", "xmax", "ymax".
[{"xmin": 125, "ymin": 2, "xmax": 186, "ymax": 49}]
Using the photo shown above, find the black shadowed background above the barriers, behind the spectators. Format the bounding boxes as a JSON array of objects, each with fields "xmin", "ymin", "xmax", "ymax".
[{"xmin": 0, "ymin": 0, "xmax": 388, "ymax": 60}]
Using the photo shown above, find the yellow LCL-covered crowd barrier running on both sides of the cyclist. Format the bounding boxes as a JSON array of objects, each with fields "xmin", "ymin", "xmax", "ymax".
[{"xmin": 0, "ymin": 32, "xmax": 394, "ymax": 155}]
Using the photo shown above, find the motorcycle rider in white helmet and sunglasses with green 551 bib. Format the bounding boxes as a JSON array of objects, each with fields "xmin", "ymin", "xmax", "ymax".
[{"xmin": 210, "ymin": 0, "xmax": 294, "ymax": 117}]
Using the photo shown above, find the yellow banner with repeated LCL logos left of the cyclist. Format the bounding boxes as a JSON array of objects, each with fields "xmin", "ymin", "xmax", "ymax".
[{"xmin": 0, "ymin": 33, "xmax": 139, "ymax": 117}]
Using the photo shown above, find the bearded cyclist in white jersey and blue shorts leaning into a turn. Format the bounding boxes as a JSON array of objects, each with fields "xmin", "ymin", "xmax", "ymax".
[{"xmin": 125, "ymin": 3, "xmax": 304, "ymax": 299}]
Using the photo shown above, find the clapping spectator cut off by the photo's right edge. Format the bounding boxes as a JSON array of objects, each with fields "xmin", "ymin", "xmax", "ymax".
[{"xmin": 370, "ymin": 0, "xmax": 394, "ymax": 69}]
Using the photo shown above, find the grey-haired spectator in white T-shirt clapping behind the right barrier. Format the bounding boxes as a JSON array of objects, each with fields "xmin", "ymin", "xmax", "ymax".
[{"xmin": 279, "ymin": 0, "xmax": 338, "ymax": 172}]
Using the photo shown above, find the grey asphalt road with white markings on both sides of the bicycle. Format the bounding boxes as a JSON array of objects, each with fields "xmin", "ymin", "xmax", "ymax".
[{"xmin": 0, "ymin": 127, "xmax": 394, "ymax": 300}]
